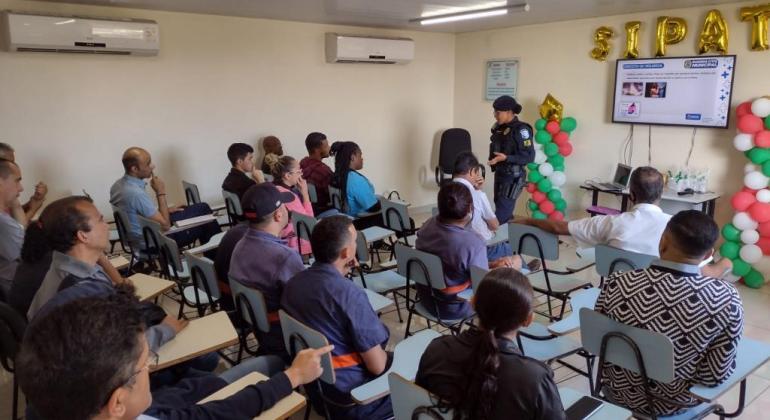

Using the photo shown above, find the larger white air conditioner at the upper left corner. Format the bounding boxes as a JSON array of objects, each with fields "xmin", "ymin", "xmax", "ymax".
[{"xmin": 0, "ymin": 11, "xmax": 160, "ymax": 56}]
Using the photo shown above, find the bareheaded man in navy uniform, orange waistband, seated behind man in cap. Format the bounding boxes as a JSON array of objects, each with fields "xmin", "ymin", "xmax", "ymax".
[{"xmin": 281, "ymin": 215, "xmax": 393, "ymax": 419}]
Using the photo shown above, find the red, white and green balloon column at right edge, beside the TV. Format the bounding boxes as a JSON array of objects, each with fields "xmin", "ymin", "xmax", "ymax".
[{"xmin": 719, "ymin": 97, "xmax": 770, "ymax": 288}]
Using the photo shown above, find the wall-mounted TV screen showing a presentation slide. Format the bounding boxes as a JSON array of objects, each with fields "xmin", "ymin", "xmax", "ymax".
[{"xmin": 612, "ymin": 55, "xmax": 735, "ymax": 128}]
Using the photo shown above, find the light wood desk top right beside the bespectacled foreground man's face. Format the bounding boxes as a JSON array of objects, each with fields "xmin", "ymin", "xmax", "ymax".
[{"xmin": 154, "ymin": 311, "xmax": 238, "ymax": 370}]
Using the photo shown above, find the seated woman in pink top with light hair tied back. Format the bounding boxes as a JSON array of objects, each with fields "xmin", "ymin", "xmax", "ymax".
[{"xmin": 265, "ymin": 153, "xmax": 315, "ymax": 255}]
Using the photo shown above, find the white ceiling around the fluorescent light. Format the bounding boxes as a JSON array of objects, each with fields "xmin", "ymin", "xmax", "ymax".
[{"xmin": 28, "ymin": 0, "xmax": 735, "ymax": 33}]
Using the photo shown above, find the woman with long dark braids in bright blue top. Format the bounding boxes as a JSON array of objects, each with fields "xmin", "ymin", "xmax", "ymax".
[{"xmin": 329, "ymin": 141, "xmax": 382, "ymax": 229}]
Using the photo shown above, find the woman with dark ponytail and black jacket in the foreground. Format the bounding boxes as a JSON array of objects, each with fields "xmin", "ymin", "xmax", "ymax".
[{"xmin": 415, "ymin": 268, "xmax": 565, "ymax": 420}]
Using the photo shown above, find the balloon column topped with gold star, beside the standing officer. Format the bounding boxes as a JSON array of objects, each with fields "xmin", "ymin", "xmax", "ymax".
[{"xmin": 527, "ymin": 93, "xmax": 577, "ymax": 220}]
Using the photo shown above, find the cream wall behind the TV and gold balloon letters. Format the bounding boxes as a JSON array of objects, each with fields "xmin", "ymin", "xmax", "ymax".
[{"xmin": 454, "ymin": 2, "xmax": 770, "ymax": 224}]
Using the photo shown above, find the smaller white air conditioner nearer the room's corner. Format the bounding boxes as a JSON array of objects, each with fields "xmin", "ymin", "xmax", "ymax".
[{"xmin": 326, "ymin": 33, "xmax": 414, "ymax": 64}]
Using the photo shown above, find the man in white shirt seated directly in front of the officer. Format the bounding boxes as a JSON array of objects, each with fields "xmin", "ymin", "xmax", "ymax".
[{"xmin": 452, "ymin": 152, "xmax": 540, "ymax": 271}]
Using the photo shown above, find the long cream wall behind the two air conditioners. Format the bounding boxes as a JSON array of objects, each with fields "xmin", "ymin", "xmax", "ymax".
[{"xmin": 0, "ymin": 0, "xmax": 455, "ymax": 213}]
